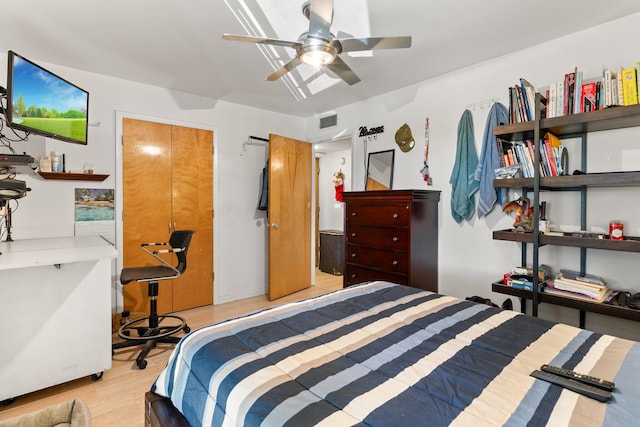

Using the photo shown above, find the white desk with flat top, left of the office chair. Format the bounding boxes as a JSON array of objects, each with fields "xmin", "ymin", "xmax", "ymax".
[{"xmin": 0, "ymin": 236, "xmax": 117, "ymax": 401}]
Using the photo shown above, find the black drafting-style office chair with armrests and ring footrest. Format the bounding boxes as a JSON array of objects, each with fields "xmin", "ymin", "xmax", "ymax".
[{"xmin": 112, "ymin": 230, "xmax": 195, "ymax": 369}]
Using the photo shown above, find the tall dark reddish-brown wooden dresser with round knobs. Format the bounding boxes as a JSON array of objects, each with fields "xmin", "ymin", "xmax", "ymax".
[{"xmin": 343, "ymin": 190, "xmax": 440, "ymax": 292}]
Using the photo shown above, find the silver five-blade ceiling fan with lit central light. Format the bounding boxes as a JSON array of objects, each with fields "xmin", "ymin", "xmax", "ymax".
[{"xmin": 222, "ymin": 0, "xmax": 411, "ymax": 85}]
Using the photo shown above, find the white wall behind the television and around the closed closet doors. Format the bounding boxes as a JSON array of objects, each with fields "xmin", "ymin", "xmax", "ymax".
[{"xmin": 0, "ymin": 52, "xmax": 305, "ymax": 306}]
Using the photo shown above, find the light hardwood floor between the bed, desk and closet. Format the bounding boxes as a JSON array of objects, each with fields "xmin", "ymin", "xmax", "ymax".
[{"xmin": 0, "ymin": 270, "xmax": 342, "ymax": 427}]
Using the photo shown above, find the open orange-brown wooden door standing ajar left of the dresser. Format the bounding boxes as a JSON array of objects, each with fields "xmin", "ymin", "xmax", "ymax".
[{"xmin": 268, "ymin": 134, "xmax": 312, "ymax": 300}]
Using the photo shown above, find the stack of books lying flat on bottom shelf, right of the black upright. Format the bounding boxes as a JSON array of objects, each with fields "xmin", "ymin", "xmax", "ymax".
[{"xmin": 544, "ymin": 270, "xmax": 611, "ymax": 302}]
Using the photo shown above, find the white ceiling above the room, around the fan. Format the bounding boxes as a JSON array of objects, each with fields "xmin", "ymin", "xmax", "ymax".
[{"xmin": 0, "ymin": 0, "xmax": 640, "ymax": 117}]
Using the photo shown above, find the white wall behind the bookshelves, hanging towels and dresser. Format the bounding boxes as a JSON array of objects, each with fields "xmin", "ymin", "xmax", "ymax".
[{"xmin": 307, "ymin": 14, "xmax": 640, "ymax": 339}]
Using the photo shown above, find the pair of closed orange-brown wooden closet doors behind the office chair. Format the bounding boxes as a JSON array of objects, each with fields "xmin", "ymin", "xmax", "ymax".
[{"xmin": 122, "ymin": 119, "xmax": 213, "ymax": 313}]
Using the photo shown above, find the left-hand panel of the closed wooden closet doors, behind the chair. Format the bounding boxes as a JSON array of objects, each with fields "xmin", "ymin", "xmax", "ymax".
[{"xmin": 122, "ymin": 119, "xmax": 172, "ymax": 313}]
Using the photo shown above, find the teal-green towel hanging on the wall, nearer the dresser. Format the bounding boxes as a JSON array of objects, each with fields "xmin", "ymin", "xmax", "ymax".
[{"xmin": 449, "ymin": 110, "xmax": 479, "ymax": 224}]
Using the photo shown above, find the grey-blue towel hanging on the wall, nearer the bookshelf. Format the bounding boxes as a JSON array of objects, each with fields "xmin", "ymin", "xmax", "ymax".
[{"xmin": 475, "ymin": 102, "xmax": 509, "ymax": 218}]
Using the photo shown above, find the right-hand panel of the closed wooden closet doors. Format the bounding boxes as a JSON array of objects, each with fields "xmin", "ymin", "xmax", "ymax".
[{"xmin": 171, "ymin": 126, "xmax": 213, "ymax": 311}]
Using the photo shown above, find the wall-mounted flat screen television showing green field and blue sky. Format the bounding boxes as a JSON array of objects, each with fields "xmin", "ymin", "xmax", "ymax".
[{"xmin": 6, "ymin": 51, "xmax": 89, "ymax": 144}]
